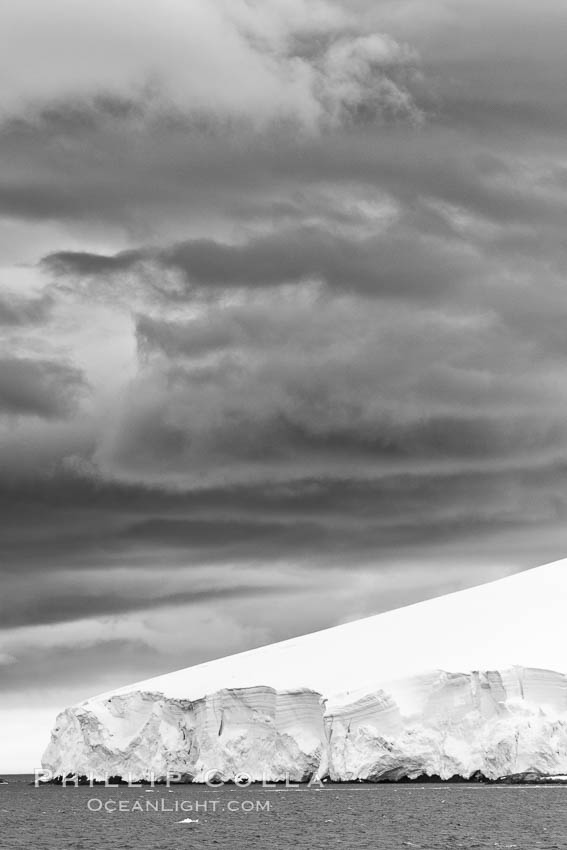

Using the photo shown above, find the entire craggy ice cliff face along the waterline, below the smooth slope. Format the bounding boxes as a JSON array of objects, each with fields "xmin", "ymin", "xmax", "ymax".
[{"xmin": 44, "ymin": 668, "xmax": 567, "ymax": 782}]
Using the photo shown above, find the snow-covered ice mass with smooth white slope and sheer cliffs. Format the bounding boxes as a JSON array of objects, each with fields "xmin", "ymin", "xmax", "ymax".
[{"xmin": 44, "ymin": 561, "xmax": 567, "ymax": 781}]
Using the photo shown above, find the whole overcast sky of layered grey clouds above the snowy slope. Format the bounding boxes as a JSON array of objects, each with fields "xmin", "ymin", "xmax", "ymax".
[{"xmin": 0, "ymin": 0, "xmax": 567, "ymax": 772}]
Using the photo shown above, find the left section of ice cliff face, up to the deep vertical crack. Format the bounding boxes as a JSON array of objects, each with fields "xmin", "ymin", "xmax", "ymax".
[{"xmin": 45, "ymin": 687, "xmax": 325, "ymax": 782}]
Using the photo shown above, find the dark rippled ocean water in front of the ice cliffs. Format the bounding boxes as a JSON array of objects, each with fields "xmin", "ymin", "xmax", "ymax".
[{"xmin": 0, "ymin": 777, "xmax": 567, "ymax": 850}]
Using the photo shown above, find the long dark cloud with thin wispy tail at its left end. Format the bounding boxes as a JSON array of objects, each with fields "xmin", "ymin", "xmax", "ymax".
[{"xmin": 43, "ymin": 228, "xmax": 475, "ymax": 299}]
